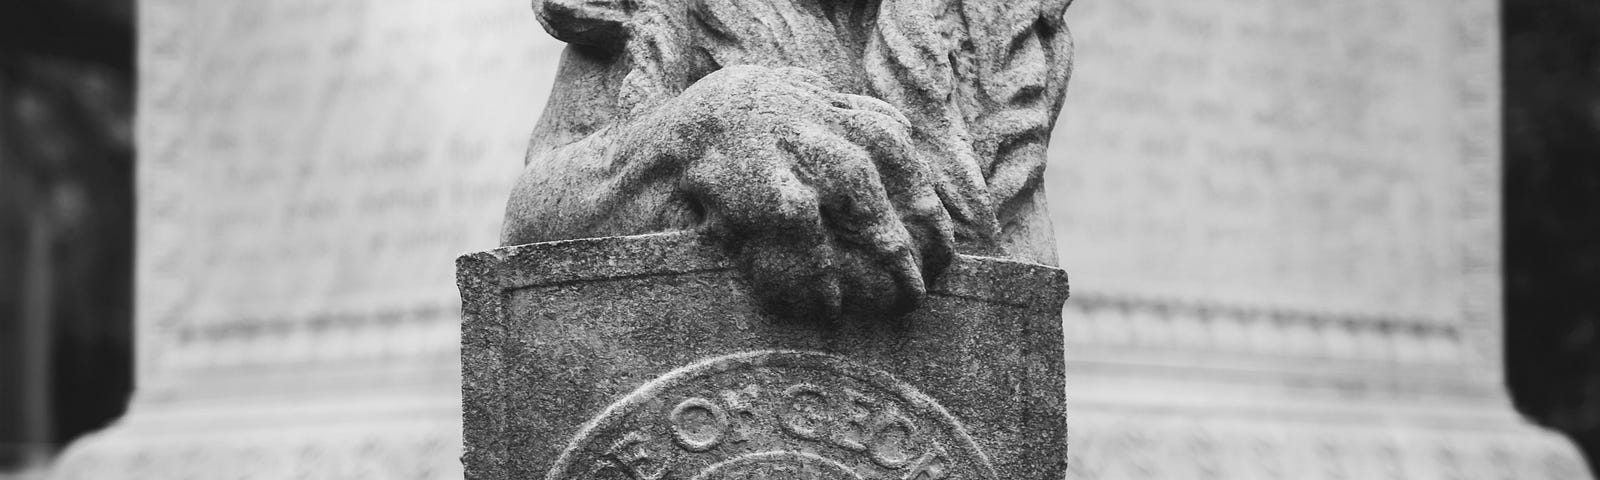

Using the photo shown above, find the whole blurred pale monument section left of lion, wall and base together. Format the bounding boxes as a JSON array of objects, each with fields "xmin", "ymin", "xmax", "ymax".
[{"xmin": 59, "ymin": 0, "xmax": 560, "ymax": 478}]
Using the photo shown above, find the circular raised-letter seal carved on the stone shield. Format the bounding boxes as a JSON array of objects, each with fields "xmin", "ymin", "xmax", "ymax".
[{"xmin": 546, "ymin": 350, "xmax": 997, "ymax": 480}]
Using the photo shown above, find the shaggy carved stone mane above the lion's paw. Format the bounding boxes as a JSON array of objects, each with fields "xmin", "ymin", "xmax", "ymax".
[{"xmin": 536, "ymin": 0, "xmax": 1072, "ymax": 252}]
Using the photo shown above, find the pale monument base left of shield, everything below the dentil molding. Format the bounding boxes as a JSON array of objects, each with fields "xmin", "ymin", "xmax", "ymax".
[{"xmin": 53, "ymin": 358, "xmax": 461, "ymax": 480}]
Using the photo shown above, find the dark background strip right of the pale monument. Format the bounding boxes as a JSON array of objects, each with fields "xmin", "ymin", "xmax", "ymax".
[{"xmin": 1501, "ymin": 0, "xmax": 1600, "ymax": 474}]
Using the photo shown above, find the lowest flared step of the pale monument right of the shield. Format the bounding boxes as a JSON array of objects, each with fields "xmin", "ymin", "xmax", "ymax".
[{"xmin": 1067, "ymin": 402, "xmax": 1590, "ymax": 480}]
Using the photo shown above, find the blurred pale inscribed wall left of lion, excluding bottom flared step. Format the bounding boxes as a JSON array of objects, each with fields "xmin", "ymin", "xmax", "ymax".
[{"xmin": 129, "ymin": 2, "xmax": 531, "ymax": 390}]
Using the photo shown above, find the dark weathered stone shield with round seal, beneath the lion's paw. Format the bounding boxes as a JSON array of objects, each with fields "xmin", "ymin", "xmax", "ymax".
[{"xmin": 458, "ymin": 234, "xmax": 1067, "ymax": 480}]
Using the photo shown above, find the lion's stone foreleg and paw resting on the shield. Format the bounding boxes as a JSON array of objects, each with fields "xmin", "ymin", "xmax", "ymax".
[{"xmin": 504, "ymin": 66, "xmax": 954, "ymax": 315}]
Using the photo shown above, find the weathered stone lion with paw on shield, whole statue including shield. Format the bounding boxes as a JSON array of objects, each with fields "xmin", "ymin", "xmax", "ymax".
[{"xmin": 473, "ymin": 0, "xmax": 1072, "ymax": 478}]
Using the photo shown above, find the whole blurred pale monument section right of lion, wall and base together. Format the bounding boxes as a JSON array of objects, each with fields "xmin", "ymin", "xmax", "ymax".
[{"xmin": 1046, "ymin": 0, "xmax": 1589, "ymax": 480}]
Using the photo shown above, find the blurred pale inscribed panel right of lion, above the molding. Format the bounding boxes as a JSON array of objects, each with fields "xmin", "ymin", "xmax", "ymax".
[{"xmin": 1050, "ymin": 0, "xmax": 1478, "ymax": 328}]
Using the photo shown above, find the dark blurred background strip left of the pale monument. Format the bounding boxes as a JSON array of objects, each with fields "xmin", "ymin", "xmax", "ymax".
[{"xmin": 0, "ymin": 0, "xmax": 134, "ymax": 472}]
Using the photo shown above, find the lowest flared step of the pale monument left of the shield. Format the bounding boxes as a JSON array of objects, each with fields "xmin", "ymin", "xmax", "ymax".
[{"xmin": 53, "ymin": 390, "xmax": 461, "ymax": 480}]
